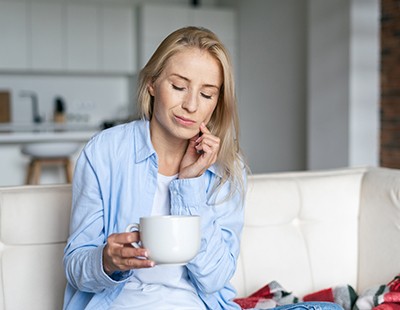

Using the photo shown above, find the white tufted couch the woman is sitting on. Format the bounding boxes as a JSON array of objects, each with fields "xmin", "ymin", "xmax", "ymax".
[{"xmin": 0, "ymin": 168, "xmax": 400, "ymax": 310}]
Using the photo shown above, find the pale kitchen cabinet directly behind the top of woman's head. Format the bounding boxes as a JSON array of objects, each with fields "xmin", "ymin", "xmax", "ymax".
[{"xmin": 139, "ymin": 4, "xmax": 236, "ymax": 67}]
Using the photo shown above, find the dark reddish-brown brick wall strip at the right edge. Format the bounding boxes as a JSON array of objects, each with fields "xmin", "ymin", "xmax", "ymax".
[{"xmin": 380, "ymin": 0, "xmax": 400, "ymax": 168}]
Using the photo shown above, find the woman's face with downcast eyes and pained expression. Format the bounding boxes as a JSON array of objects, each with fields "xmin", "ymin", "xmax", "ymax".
[{"xmin": 149, "ymin": 48, "xmax": 223, "ymax": 140}]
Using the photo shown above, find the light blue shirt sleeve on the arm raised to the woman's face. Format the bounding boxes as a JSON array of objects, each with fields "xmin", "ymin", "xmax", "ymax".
[{"xmin": 170, "ymin": 171, "xmax": 244, "ymax": 294}]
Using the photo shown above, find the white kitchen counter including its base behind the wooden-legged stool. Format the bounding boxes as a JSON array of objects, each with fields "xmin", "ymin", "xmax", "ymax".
[{"xmin": 0, "ymin": 122, "xmax": 100, "ymax": 186}]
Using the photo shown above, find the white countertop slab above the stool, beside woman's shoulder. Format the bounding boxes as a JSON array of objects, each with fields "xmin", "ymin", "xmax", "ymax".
[{"xmin": 0, "ymin": 123, "xmax": 100, "ymax": 145}]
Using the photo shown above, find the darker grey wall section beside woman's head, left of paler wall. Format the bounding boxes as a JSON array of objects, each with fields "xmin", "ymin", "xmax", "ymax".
[{"xmin": 233, "ymin": 0, "xmax": 307, "ymax": 173}]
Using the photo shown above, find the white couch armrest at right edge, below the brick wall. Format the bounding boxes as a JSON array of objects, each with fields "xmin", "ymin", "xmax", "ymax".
[{"xmin": 358, "ymin": 168, "xmax": 400, "ymax": 291}]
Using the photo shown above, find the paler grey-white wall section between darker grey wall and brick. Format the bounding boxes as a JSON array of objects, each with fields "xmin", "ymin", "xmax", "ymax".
[{"xmin": 308, "ymin": 0, "xmax": 379, "ymax": 169}]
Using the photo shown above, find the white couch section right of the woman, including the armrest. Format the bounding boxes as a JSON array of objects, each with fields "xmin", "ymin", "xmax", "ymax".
[{"xmin": 232, "ymin": 168, "xmax": 400, "ymax": 297}]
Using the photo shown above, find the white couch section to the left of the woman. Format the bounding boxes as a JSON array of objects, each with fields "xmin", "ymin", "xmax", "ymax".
[{"xmin": 0, "ymin": 185, "xmax": 71, "ymax": 310}]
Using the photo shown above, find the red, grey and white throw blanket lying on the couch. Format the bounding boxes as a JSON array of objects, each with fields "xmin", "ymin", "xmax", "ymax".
[{"xmin": 235, "ymin": 274, "xmax": 400, "ymax": 310}]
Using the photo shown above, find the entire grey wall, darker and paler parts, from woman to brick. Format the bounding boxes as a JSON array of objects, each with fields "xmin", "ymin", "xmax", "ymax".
[{"xmin": 220, "ymin": 0, "xmax": 379, "ymax": 173}]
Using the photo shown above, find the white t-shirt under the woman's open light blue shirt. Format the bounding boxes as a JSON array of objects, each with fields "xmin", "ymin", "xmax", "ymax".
[{"xmin": 110, "ymin": 174, "xmax": 206, "ymax": 310}]
